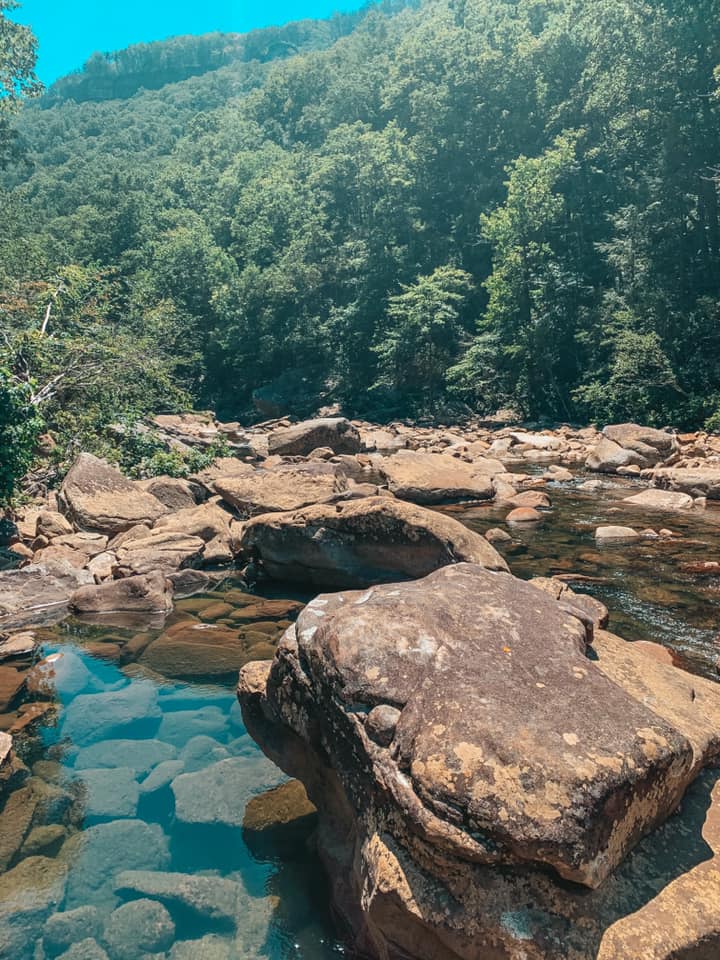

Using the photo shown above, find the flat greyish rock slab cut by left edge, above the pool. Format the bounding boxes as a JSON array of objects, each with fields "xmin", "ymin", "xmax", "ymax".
[{"xmin": 0, "ymin": 560, "xmax": 95, "ymax": 628}]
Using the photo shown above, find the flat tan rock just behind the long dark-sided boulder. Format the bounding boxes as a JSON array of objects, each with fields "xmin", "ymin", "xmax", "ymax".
[{"xmin": 215, "ymin": 463, "xmax": 347, "ymax": 517}]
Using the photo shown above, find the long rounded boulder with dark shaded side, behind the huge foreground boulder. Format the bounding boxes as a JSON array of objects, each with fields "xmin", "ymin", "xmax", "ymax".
[{"xmin": 239, "ymin": 497, "xmax": 507, "ymax": 588}]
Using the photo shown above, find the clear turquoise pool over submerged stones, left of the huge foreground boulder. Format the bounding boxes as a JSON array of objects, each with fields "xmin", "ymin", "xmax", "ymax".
[{"xmin": 0, "ymin": 585, "xmax": 343, "ymax": 960}]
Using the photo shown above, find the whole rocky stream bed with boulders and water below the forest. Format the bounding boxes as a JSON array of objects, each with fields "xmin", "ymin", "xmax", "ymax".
[{"xmin": 0, "ymin": 415, "xmax": 720, "ymax": 960}]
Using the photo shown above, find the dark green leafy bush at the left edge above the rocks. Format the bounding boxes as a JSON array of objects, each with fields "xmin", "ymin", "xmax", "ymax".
[{"xmin": 0, "ymin": 367, "xmax": 43, "ymax": 506}]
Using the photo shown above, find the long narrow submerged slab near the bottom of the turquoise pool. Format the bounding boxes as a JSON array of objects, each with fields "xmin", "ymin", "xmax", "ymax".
[{"xmin": 114, "ymin": 870, "xmax": 247, "ymax": 926}]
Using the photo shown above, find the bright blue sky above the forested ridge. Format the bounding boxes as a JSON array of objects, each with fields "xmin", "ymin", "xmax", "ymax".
[{"xmin": 12, "ymin": 0, "xmax": 363, "ymax": 84}]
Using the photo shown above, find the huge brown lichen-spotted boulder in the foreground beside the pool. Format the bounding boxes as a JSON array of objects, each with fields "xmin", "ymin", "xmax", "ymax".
[{"xmin": 242, "ymin": 565, "xmax": 704, "ymax": 887}]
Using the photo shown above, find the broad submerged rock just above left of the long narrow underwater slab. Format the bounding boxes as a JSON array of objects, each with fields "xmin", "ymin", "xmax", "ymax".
[{"xmin": 60, "ymin": 820, "xmax": 170, "ymax": 909}]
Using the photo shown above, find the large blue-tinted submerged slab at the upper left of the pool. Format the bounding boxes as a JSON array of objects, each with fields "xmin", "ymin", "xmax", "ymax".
[{"xmin": 62, "ymin": 681, "xmax": 161, "ymax": 744}]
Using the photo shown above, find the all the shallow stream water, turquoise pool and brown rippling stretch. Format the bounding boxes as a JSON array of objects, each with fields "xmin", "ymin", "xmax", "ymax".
[{"xmin": 0, "ymin": 478, "xmax": 720, "ymax": 960}]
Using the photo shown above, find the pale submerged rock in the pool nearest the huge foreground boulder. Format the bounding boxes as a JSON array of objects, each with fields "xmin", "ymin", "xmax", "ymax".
[{"xmin": 171, "ymin": 758, "xmax": 282, "ymax": 827}]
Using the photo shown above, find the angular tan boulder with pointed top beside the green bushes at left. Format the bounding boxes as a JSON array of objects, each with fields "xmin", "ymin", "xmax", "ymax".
[{"xmin": 58, "ymin": 453, "xmax": 168, "ymax": 536}]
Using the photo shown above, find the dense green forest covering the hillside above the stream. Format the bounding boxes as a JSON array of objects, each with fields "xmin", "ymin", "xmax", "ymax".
[{"xmin": 0, "ymin": 0, "xmax": 720, "ymax": 492}]
